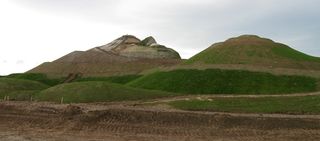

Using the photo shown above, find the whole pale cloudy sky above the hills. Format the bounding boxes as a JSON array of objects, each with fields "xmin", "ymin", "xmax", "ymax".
[{"xmin": 0, "ymin": 0, "xmax": 320, "ymax": 75}]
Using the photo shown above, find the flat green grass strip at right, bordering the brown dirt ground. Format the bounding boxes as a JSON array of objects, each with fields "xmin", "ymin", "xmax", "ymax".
[{"xmin": 169, "ymin": 96, "xmax": 320, "ymax": 114}]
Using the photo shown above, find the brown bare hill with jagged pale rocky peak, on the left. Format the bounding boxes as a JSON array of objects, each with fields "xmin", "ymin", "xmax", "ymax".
[{"xmin": 27, "ymin": 35, "xmax": 181, "ymax": 76}]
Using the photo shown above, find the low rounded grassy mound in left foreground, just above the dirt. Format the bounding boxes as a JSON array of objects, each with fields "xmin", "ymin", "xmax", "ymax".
[{"xmin": 35, "ymin": 81, "xmax": 179, "ymax": 103}]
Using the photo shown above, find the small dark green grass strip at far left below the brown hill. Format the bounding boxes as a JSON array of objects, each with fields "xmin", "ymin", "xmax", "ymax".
[{"xmin": 6, "ymin": 73, "xmax": 63, "ymax": 86}]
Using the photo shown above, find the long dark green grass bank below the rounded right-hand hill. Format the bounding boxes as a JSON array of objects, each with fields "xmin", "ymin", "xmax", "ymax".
[{"xmin": 128, "ymin": 69, "xmax": 317, "ymax": 94}]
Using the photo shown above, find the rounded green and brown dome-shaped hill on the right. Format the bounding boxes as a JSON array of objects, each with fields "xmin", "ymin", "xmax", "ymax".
[{"xmin": 185, "ymin": 35, "xmax": 320, "ymax": 69}]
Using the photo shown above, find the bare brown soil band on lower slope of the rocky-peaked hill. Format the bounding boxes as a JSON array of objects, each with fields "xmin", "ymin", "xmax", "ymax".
[{"xmin": 28, "ymin": 59, "xmax": 181, "ymax": 76}]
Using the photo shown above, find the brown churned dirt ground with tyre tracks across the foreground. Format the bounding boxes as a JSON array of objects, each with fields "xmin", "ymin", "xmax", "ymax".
[{"xmin": 0, "ymin": 102, "xmax": 320, "ymax": 141}]
